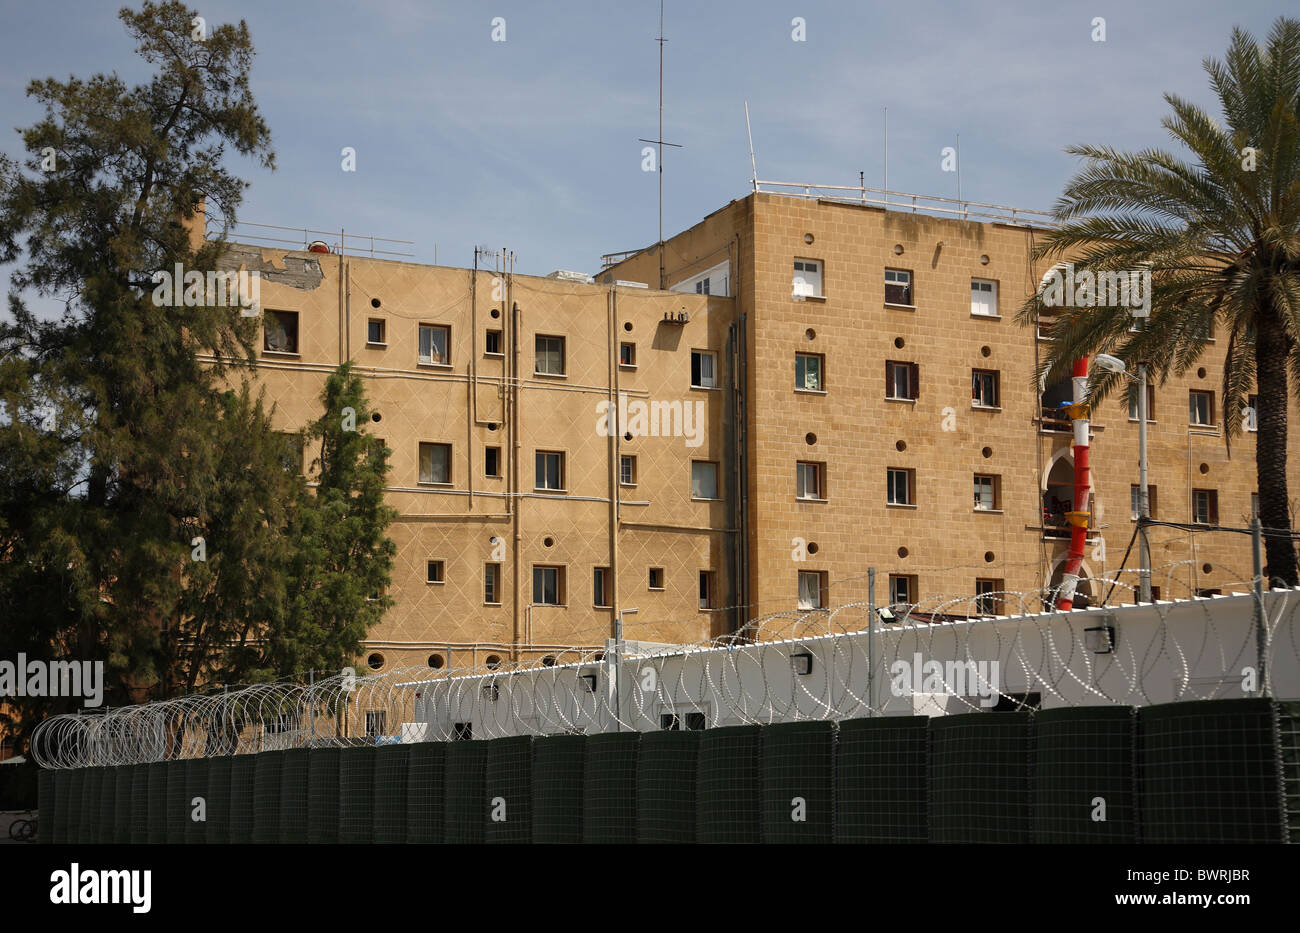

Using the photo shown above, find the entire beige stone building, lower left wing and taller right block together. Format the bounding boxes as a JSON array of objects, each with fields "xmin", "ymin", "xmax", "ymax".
[{"xmin": 218, "ymin": 191, "xmax": 1300, "ymax": 671}]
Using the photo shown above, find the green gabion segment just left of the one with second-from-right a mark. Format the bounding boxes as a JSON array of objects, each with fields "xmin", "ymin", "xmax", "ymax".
[{"xmin": 696, "ymin": 725, "xmax": 762, "ymax": 843}]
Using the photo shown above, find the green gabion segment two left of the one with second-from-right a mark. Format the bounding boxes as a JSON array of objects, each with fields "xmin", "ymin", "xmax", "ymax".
[{"xmin": 636, "ymin": 729, "xmax": 703, "ymax": 843}]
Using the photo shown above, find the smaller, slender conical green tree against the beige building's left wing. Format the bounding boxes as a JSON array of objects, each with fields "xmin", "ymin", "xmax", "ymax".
[{"xmin": 267, "ymin": 364, "xmax": 397, "ymax": 671}]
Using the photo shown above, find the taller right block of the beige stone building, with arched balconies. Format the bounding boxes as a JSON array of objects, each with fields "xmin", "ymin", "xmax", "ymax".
[{"xmin": 599, "ymin": 190, "xmax": 1297, "ymax": 628}]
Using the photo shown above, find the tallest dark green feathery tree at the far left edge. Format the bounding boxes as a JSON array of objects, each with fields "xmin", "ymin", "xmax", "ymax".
[{"xmin": 0, "ymin": 3, "xmax": 280, "ymax": 738}]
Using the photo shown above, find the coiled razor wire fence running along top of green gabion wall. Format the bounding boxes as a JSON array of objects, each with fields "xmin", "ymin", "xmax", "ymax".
[{"xmin": 31, "ymin": 573, "xmax": 1300, "ymax": 769}]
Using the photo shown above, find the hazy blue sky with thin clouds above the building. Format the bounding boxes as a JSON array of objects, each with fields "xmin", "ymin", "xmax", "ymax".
[{"xmin": 0, "ymin": 0, "xmax": 1295, "ymax": 292}]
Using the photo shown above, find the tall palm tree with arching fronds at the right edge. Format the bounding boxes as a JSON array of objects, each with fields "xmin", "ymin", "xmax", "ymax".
[{"xmin": 1019, "ymin": 18, "xmax": 1300, "ymax": 586}]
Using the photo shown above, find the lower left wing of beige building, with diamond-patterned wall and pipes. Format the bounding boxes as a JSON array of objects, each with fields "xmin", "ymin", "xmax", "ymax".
[{"xmin": 214, "ymin": 237, "xmax": 741, "ymax": 671}]
